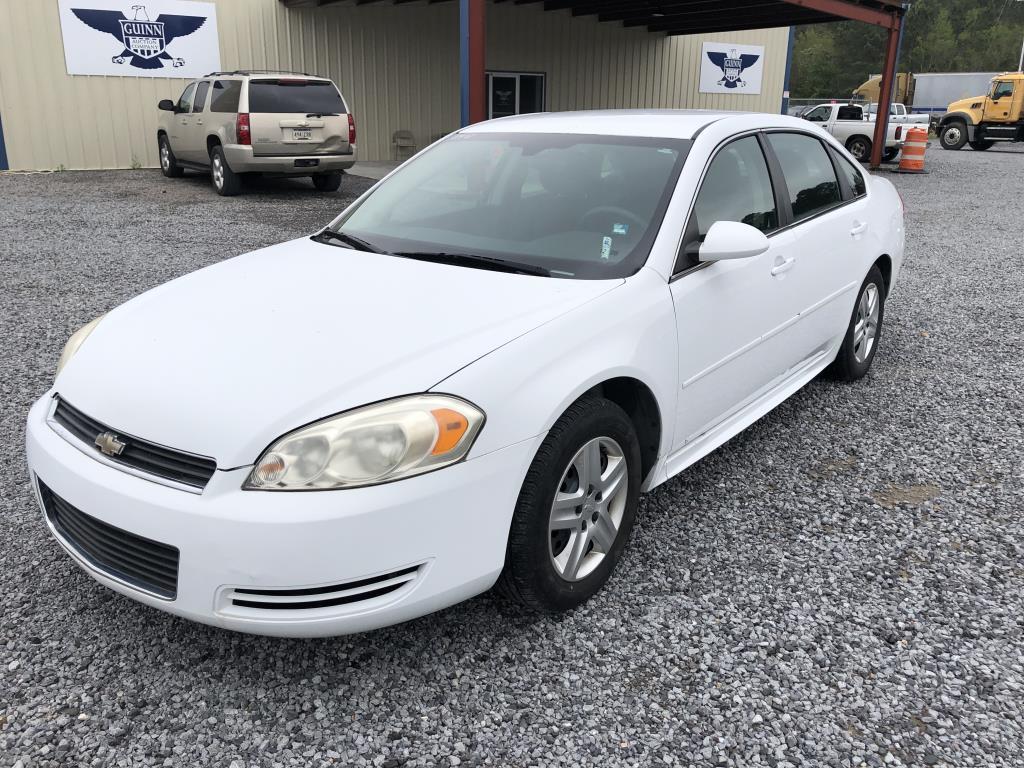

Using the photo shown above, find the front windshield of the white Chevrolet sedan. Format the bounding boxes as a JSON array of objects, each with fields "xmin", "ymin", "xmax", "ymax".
[{"xmin": 334, "ymin": 133, "xmax": 690, "ymax": 280}]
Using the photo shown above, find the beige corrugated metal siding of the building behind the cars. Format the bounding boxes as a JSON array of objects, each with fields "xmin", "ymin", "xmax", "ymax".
[{"xmin": 0, "ymin": 0, "xmax": 787, "ymax": 169}]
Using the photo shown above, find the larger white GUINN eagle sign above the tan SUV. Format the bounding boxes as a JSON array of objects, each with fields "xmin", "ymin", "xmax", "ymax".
[{"xmin": 57, "ymin": 0, "xmax": 220, "ymax": 78}]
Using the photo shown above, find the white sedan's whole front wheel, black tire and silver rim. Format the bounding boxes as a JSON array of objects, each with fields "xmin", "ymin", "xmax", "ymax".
[{"xmin": 498, "ymin": 397, "xmax": 642, "ymax": 612}]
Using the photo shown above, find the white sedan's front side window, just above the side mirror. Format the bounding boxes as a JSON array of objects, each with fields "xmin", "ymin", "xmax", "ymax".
[{"xmin": 691, "ymin": 136, "xmax": 778, "ymax": 239}]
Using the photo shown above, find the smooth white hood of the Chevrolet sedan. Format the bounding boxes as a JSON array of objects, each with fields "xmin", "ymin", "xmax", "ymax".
[{"xmin": 55, "ymin": 239, "xmax": 623, "ymax": 469}]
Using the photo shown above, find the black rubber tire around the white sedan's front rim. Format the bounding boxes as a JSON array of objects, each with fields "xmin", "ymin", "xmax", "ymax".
[{"xmin": 497, "ymin": 397, "xmax": 642, "ymax": 612}]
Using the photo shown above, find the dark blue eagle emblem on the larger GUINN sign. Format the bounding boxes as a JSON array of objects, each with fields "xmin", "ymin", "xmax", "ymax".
[{"xmin": 71, "ymin": 5, "xmax": 206, "ymax": 70}]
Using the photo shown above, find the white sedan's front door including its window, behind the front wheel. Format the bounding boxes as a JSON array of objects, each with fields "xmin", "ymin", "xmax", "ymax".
[{"xmin": 671, "ymin": 135, "xmax": 802, "ymax": 452}]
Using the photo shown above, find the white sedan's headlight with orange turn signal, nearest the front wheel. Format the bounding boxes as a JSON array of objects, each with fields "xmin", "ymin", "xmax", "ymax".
[{"xmin": 242, "ymin": 394, "xmax": 483, "ymax": 490}]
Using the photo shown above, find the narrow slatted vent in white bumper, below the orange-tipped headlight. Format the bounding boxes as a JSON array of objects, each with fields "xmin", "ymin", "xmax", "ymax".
[{"xmin": 228, "ymin": 565, "xmax": 420, "ymax": 610}]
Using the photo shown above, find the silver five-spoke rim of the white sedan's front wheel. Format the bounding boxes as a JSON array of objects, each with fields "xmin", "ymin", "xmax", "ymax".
[{"xmin": 548, "ymin": 437, "xmax": 629, "ymax": 582}]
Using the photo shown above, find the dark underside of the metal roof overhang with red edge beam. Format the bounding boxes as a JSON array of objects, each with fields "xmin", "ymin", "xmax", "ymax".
[{"xmin": 282, "ymin": 0, "xmax": 903, "ymax": 35}]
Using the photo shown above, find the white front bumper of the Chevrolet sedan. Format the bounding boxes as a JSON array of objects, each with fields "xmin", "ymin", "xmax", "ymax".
[{"xmin": 27, "ymin": 394, "xmax": 541, "ymax": 637}]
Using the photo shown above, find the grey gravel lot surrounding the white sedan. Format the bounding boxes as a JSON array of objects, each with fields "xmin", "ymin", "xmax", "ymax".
[{"xmin": 0, "ymin": 146, "xmax": 1024, "ymax": 768}]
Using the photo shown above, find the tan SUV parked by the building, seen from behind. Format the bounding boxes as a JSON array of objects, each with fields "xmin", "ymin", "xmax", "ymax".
[{"xmin": 157, "ymin": 71, "xmax": 355, "ymax": 195}]
